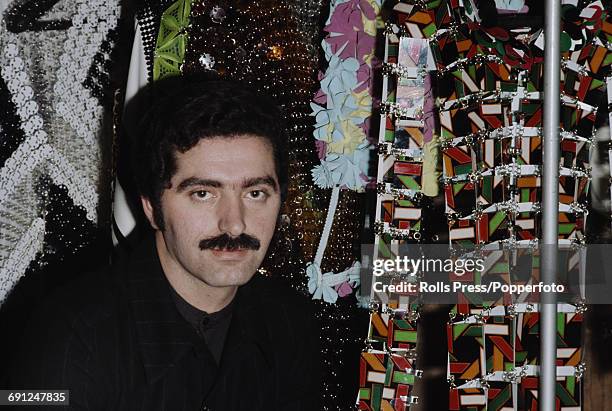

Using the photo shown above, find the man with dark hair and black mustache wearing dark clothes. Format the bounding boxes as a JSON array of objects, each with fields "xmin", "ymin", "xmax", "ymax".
[{"xmin": 11, "ymin": 77, "xmax": 320, "ymax": 411}]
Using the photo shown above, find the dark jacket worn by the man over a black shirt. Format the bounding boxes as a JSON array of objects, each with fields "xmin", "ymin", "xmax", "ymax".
[{"xmin": 9, "ymin": 241, "xmax": 321, "ymax": 411}]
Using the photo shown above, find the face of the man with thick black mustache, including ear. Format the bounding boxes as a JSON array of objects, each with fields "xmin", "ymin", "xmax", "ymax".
[{"xmin": 143, "ymin": 135, "xmax": 280, "ymax": 287}]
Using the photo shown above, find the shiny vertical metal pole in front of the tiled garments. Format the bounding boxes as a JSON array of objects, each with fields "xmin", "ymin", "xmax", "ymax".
[{"xmin": 538, "ymin": 0, "xmax": 561, "ymax": 411}]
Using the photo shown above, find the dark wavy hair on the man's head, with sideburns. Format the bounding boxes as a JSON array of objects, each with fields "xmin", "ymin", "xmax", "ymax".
[{"xmin": 124, "ymin": 75, "xmax": 287, "ymax": 230}]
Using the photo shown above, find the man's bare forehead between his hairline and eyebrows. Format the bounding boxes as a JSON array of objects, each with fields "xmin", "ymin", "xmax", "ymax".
[{"xmin": 173, "ymin": 135, "xmax": 278, "ymax": 181}]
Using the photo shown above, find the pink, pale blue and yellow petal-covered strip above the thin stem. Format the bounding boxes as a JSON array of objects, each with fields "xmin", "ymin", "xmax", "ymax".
[{"xmin": 311, "ymin": 0, "xmax": 380, "ymax": 191}]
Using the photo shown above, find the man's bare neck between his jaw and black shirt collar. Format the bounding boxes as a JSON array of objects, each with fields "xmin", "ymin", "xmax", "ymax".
[{"xmin": 155, "ymin": 231, "xmax": 238, "ymax": 313}]
